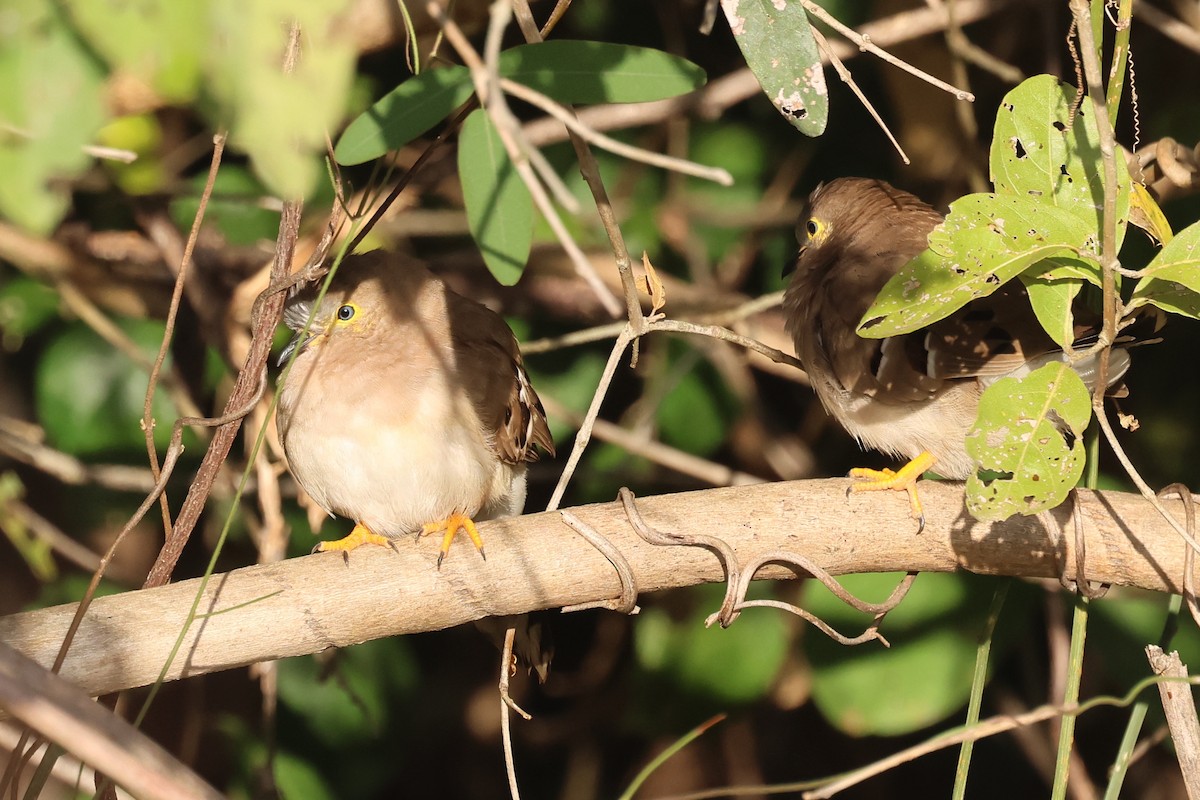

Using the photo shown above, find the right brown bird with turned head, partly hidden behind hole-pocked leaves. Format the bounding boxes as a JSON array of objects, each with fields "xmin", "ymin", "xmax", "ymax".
[{"xmin": 784, "ymin": 178, "xmax": 1129, "ymax": 518}]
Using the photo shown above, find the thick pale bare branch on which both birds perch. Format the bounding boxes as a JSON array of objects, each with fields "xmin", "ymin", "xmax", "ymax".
[{"xmin": 0, "ymin": 480, "xmax": 1183, "ymax": 694}]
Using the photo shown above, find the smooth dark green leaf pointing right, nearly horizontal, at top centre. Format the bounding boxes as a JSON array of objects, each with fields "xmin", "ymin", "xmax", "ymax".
[{"xmin": 499, "ymin": 40, "xmax": 706, "ymax": 103}]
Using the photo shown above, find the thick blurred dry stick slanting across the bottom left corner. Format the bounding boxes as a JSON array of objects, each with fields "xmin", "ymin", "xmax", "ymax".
[{"xmin": 0, "ymin": 642, "xmax": 222, "ymax": 800}]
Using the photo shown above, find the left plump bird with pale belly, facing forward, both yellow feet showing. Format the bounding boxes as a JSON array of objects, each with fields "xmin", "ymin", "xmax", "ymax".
[{"xmin": 276, "ymin": 251, "xmax": 554, "ymax": 679}]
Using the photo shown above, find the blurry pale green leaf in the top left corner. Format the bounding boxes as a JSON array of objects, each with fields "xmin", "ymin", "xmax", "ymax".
[{"xmin": 0, "ymin": 0, "xmax": 106, "ymax": 234}]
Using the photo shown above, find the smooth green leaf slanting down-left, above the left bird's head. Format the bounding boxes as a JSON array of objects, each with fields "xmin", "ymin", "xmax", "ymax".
[{"xmin": 334, "ymin": 65, "xmax": 475, "ymax": 166}]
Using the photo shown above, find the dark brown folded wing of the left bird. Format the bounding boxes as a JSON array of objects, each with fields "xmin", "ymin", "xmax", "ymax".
[{"xmin": 446, "ymin": 289, "xmax": 554, "ymax": 464}]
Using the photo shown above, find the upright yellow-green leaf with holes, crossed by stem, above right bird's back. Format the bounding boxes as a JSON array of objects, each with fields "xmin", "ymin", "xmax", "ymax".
[{"xmin": 990, "ymin": 76, "xmax": 1130, "ymax": 246}]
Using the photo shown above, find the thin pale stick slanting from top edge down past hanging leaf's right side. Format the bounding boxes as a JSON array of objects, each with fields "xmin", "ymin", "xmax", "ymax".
[{"xmin": 426, "ymin": 0, "xmax": 620, "ymax": 317}]
